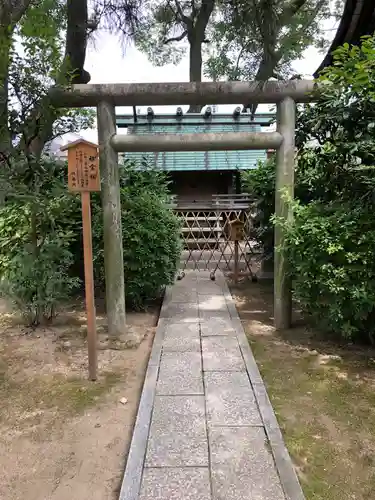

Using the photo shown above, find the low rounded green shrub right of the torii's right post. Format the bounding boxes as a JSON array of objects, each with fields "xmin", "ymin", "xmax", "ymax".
[{"xmin": 282, "ymin": 202, "xmax": 375, "ymax": 342}]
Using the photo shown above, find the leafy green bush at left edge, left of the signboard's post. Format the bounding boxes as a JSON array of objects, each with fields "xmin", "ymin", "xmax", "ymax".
[{"xmin": 0, "ymin": 158, "xmax": 81, "ymax": 326}]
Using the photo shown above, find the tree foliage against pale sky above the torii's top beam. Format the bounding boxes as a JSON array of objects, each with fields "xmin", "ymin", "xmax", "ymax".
[{"xmin": 135, "ymin": 0, "xmax": 344, "ymax": 110}]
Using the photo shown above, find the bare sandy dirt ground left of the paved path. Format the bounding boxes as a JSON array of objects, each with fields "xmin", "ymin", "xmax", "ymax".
[{"xmin": 0, "ymin": 296, "xmax": 159, "ymax": 500}]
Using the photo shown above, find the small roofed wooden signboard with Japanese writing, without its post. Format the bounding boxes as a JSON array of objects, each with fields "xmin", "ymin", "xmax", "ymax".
[{"xmin": 61, "ymin": 139, "xmax": 100, "ymax": 192}]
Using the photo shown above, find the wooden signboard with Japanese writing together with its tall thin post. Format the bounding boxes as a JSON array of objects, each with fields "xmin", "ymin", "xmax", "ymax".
[{"xmin": 61, "ymin": 139, "xmax": 100, "ymax": 380}]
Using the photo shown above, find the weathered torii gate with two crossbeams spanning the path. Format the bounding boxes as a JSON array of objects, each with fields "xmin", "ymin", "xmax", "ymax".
[{"xmin": 50, "ymin": 80, "xmax": 317, "ymax": 336}]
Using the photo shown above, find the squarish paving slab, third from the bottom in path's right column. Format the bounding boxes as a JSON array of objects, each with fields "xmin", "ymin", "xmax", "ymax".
[{"xmin": 202, "ymin": 335, "xmax": 245, "ymax": 372}]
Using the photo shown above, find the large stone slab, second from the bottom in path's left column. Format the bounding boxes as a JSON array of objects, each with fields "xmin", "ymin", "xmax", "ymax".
[{"xmin": 145, "ymin": 396, "xmax": 208, "ymax": 467}]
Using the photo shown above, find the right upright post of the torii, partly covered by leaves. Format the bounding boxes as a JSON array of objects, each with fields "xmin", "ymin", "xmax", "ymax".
[{"xmin": 274, "ymin": 97, "xmax": 296, "ymax": 330}]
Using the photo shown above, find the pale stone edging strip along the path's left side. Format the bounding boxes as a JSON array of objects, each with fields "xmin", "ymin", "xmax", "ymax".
[{"xmin": 119, "ymin": 287, "xmax": 172, "ymax": 500}]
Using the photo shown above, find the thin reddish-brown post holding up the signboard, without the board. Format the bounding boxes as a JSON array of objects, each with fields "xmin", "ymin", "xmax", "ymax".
[{"xmin": 81, "ymin": 191, "xmax": 98, "ymax": 380}]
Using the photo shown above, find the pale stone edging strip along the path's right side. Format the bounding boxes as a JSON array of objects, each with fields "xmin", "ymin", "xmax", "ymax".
[{"xmin": 220, "ymin": 277, "xmax": 305, "ymax": 500}]
